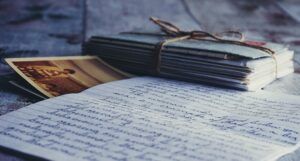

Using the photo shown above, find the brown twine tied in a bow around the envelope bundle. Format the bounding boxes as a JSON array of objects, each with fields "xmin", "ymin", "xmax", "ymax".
[{"xmin": 123, "ymin": 17, "xmax": 277, "ymax": 78}]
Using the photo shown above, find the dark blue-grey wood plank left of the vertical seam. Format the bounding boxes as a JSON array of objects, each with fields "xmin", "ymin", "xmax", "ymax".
[{"xmin": 0, "ymin": 0, "xmax": 84, "ymax": 74}]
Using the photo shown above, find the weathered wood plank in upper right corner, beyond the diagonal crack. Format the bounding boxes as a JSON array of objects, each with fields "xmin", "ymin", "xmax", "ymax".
[{"xmin": 184, "ymin": 0, "xmax": 300, "ymax": 72}]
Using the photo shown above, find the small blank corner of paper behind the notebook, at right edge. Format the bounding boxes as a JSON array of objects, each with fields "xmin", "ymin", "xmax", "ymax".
[{"xmin": 264, "ymin": 73, "xmax": 300, "ymax": 95}]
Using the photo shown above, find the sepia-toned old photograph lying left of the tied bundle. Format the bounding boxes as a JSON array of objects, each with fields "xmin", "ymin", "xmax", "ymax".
[{"xmin": 6, "ymin": 56, "xmax": 129, "ymax": 97}]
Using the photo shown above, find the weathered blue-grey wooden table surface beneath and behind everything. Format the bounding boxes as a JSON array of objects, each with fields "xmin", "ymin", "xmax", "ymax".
[{"xmin": 0, "ymin": 0, "xmax": 300, "ymax": 161}]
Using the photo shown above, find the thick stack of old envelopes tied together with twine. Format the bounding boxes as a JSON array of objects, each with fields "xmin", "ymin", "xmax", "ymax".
[{"xmin": 83, "ymin": 33, "xmax": 294, "ymax": 91}]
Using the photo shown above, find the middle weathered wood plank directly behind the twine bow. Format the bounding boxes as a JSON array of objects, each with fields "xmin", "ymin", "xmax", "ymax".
[{"xmin": 86, "ymin": 0, "xmax": 199, "ymax": 38}]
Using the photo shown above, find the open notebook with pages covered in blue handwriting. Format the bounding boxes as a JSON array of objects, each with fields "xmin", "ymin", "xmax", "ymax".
[{"xmin": 0, "ymin": 77, "xmax": 300, "ymax": 161}]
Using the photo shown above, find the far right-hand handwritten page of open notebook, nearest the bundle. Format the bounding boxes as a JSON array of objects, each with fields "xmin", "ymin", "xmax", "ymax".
[{"xmin": 82, "ymin": 77, "xmax": 300, "ymax": 158}]
